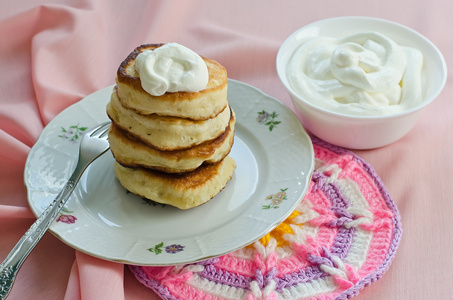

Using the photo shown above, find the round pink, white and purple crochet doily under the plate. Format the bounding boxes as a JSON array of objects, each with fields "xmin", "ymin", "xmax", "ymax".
[{"xmin": 129, "ymin": 138, "xmax": 402, "ymax": 300}]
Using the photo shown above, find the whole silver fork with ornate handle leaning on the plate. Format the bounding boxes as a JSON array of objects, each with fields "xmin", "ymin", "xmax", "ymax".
[{"xmin": 0, "ymin": 122, "xmax": 110, "ymax": 299}]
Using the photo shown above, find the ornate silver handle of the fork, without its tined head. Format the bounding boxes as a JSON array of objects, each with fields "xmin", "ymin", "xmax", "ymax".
[{"xmin": 0, "ymin": 164, "xmax": 85, "ymax": 300}]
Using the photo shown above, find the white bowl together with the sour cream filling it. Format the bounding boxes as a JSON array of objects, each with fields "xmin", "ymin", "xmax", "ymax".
[{"xmin": 277, "ymin": 17, "xmax": 447, "ymax": 149}]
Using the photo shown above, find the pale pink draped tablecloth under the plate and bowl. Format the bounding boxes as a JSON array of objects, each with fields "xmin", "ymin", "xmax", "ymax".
[{"xmin": 0, "ymin": 0, "xmax": 453, "ymax": 300}]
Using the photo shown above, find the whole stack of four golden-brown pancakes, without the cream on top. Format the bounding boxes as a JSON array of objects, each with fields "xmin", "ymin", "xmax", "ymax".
[{"xmin": 107, "ymin": 44, "xmax": 236, "ymax": 209}]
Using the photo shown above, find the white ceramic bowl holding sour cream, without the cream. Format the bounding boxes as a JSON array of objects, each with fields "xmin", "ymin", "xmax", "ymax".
[{"xmin": 277, "ymin": 17, "xmax": 447, "ymax": 149}]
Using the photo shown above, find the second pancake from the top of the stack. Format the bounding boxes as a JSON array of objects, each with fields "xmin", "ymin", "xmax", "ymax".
[{"xmin": 107, "ymin": 88, "xmax": 230, "ymax": 150}]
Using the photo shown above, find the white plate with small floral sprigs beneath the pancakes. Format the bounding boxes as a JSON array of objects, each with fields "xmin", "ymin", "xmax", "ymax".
[{"xmin": 24, "ymin": 80, "xmax": 314, "ymax": 265}]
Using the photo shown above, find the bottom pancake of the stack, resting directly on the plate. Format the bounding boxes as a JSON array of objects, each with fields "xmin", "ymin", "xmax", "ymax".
[{"xmin": 114, "ymin": 156, "xmax": 236, "ymax": 209}]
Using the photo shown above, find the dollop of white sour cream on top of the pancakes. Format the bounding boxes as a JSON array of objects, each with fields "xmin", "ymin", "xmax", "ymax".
[{"xmin": 135, "ymin": 43, "xmax": 209, "ymax": 96}]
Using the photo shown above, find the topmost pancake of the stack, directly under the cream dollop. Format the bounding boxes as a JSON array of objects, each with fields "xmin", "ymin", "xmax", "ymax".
[{"xmin": 116, "ymin": 44, "xmax": 228, "ymax": 120}]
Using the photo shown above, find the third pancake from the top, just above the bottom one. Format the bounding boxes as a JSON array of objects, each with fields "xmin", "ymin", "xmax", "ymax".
[{"xmin": 109, "ymin": 110, "xmax": 235, "ymax": 173}]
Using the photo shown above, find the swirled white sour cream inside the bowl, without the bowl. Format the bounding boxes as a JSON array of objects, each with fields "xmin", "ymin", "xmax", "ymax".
[{"xmin": 287, "ymin": 32, "xmax": 426, "ymax": 116}]
